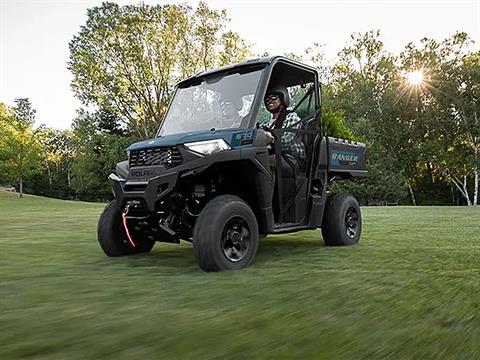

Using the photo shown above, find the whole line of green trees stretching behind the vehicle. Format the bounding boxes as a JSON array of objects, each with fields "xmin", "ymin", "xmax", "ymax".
[{"xmin": 0, "ymin": 3, "xmax": 480, "ymax": 205}]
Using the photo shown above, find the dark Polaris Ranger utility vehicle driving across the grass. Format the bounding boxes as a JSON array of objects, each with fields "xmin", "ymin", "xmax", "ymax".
[{"xmin": 98, "ymin": 56, "xmax": 367, "ymax": 271}]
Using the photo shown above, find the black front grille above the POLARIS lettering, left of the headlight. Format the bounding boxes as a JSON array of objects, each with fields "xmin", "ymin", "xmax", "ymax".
[{"xmin": 128, "ymin": 147, "xmax": 183, "ymax": 168}]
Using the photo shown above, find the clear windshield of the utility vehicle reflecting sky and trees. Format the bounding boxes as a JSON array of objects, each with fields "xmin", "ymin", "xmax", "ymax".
[{"xmin": 158, "ymin": 70, "xmax": 262, "ymax": 136}]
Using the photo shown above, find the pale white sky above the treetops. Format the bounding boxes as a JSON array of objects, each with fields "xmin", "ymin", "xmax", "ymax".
[{"xmin": 0, "ymin": 0, "xmax": 480, "ymax": 130}]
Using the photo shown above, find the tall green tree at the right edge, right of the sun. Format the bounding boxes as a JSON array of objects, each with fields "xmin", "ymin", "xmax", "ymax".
[{"xmin": 401, "ymin": 33, "xmax": 480, "ymax": 205}]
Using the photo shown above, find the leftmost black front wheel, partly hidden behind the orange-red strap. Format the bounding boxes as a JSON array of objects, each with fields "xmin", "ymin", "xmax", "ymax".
[{"xmin": 97, "ymin": 200, "xmax": 155, "ymax": 256}]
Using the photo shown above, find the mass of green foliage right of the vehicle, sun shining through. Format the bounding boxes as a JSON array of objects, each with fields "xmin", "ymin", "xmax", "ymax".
[{"xmin": 306, "ymin": 31, "xmax": 480, "ymax": 204}]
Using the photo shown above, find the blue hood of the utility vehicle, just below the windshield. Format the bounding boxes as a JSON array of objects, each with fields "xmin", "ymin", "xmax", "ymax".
[{"xmin": 127, "ymin": 129, "xmax": 255, "ymax": 150}]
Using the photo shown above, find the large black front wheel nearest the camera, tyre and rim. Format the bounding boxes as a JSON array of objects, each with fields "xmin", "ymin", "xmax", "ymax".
[{"xmin": 193, "ymin": 195, "xmax": 258, "ymax": 271}]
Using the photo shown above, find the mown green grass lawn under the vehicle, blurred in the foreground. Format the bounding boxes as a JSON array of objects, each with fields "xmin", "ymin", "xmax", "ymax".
[{"xmin": 0, "ymin": 193, "xmax": 480, "ymax": 359}]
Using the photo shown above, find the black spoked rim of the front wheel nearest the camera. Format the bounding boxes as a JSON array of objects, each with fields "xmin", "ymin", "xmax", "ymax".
[{"xmin": 222, "ymin": 217, "xmax": 251, "ymax": 262}]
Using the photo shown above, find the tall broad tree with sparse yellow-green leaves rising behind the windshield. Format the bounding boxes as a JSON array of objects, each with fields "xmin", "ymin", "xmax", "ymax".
[{"xmin": 68, "ymin": 2, "xmax": 253, "ymax": 138}]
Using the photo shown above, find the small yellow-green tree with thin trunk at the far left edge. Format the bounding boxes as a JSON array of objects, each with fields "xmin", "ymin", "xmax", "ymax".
[{"xmin": 0, "ymin": 99, "xmax": 42, "ymax": 197}]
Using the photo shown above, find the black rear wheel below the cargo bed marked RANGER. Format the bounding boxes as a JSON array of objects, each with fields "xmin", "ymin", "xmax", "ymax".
[{"xmin": 322, "ymin": 194, "xmax": 362, "ymax": 246}]
